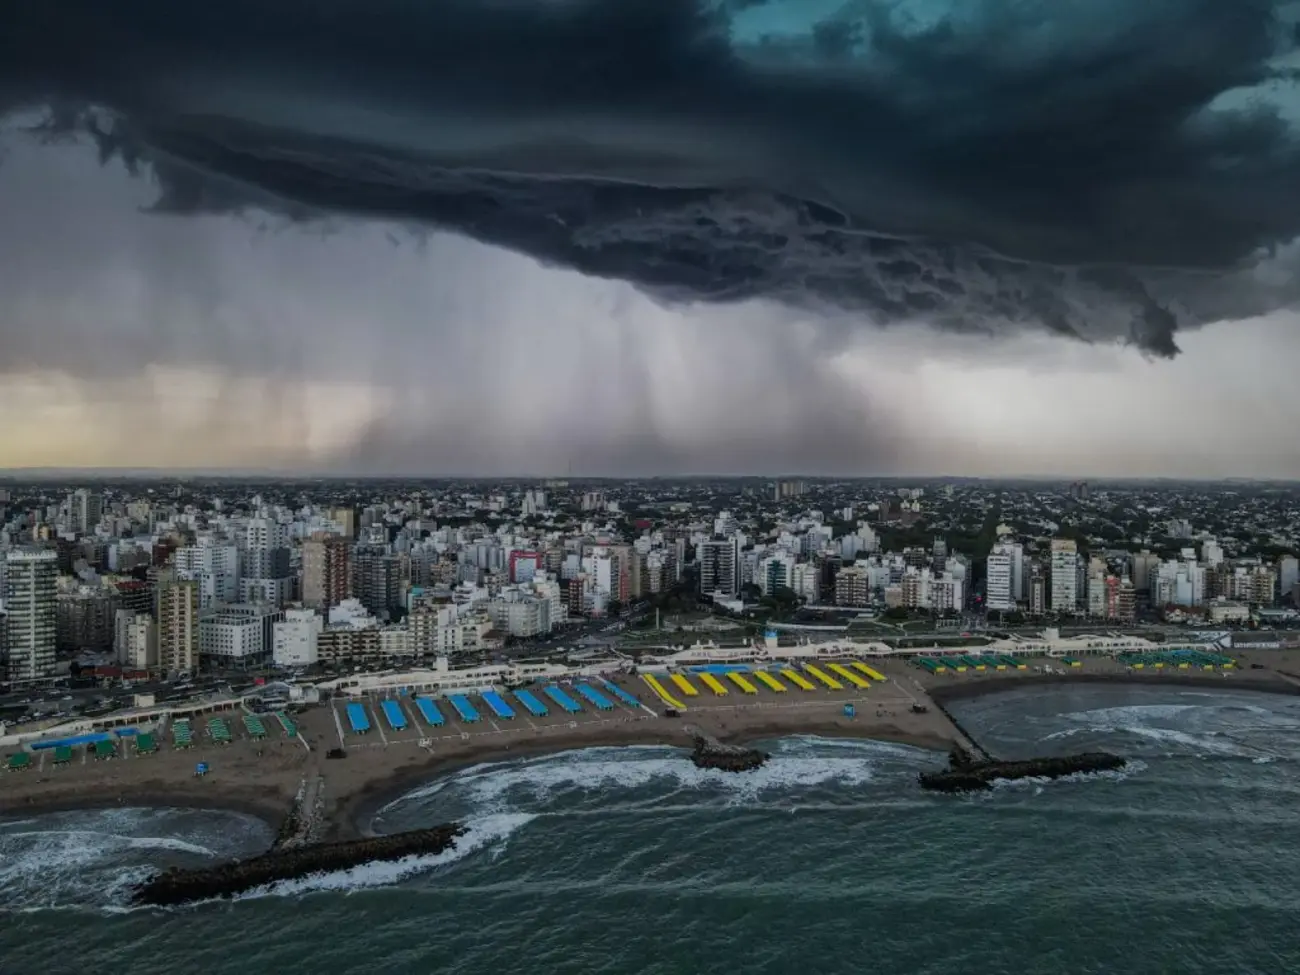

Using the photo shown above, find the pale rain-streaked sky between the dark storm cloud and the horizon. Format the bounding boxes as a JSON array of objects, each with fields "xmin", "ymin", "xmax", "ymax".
[{"xmin": 0, "ymin": 140, "xmax": 1300, "ymax": 477}]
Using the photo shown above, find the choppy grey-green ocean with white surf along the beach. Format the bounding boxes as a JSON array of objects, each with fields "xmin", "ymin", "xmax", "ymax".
[{"xmin": 0, "ymin": 685, "xmax": 1300, "ymax": 975}]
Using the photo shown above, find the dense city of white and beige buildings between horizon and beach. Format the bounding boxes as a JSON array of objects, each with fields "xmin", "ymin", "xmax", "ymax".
[{"xmin": 0, "ymin": 478, "xmax": 1300, "ymax": 707}]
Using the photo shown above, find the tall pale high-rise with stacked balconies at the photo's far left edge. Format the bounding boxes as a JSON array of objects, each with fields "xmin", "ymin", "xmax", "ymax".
[{"xmin": 4, "ymin": 549, "xmax": 59, "ymax": 684}]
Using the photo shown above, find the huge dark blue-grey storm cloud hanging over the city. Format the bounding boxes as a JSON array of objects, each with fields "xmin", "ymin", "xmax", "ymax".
[{"xmin": 0, "ymin": 0, "xmax": 1300, "ymax": 355}]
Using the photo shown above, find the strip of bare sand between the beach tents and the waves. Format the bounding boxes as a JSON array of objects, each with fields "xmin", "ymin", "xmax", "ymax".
[{"xmin": 0, "ymin": 660, "xmax": 1300, "ymax": 841}]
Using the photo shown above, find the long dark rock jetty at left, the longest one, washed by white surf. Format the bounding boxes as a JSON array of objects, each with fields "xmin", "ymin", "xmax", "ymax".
[{"xmin": 133, "ymin": 823, "xmax": 465, "ymax": 906}]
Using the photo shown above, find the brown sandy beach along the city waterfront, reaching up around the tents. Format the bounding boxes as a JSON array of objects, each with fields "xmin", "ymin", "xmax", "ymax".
[{"xmin": 0, "ymin": 660, "xmax": 1300, "ymax": 839}]
